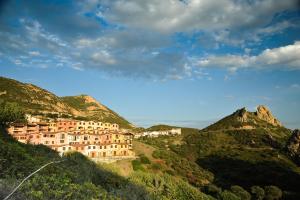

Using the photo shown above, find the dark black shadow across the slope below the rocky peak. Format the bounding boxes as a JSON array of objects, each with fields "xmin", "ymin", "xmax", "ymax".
[{"xmin": 197, "ymin": 156, "xmax": 300, "ymax": 193}]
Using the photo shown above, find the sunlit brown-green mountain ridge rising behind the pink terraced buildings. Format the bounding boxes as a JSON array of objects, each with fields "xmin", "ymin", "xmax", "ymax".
[{"xmin": 0, "ymin": 77, "xmax": 133, "ymax": 128}]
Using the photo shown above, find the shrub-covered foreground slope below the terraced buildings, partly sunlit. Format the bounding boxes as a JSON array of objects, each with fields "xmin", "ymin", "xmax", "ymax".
[{"xmin": 0, "ymin": 127, "xmax": 213, "ymax": 200}]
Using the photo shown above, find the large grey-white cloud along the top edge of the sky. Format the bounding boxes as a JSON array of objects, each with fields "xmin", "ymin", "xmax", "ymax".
[{"xmin": 102, "ymin": 0, "xmax": 298, "ymax": 33}]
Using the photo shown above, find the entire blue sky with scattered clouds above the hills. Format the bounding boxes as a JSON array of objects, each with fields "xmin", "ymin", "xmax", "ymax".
[{"xmin": 0, "ymin": 0, "xmax": 300, "ymax": 128}]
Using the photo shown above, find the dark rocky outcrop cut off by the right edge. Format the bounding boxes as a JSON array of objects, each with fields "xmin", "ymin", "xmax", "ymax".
[{"xmin": 287, "ymin": 129, "xmax": 300, "ymax": 165}]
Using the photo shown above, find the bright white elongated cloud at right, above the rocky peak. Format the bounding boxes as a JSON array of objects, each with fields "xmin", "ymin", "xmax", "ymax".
[{"xmin": 195, "ymin": 41, "xmax": 300, "ymax": 71}]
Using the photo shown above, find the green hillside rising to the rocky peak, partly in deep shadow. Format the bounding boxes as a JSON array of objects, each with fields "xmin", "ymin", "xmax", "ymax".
[{"xmin": 139, "ymin": 106, "xmax": 300, "ymax": 199}]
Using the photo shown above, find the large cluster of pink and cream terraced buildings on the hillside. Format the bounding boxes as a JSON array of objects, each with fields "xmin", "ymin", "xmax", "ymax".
[{"xmin": 8, "ymin": 120, "xmax": 135, "ymax": 162}]
